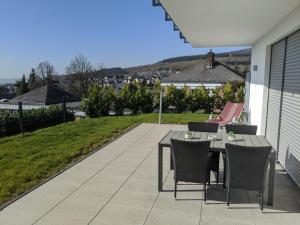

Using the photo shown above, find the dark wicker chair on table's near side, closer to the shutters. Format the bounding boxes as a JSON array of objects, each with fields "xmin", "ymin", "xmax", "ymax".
[{"xmin": 226, "ymin": 144, "xmax": 272, "ymax": 210}]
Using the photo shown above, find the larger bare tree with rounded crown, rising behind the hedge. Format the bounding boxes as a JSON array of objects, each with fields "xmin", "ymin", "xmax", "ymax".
[{"xmin": 65, "ymin": 54, "xmax": 93, "ymax": 96}]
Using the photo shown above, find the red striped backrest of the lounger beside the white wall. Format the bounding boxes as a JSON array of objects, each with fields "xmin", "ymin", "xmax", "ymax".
[{"xmin": 220, "ymin": 102, "xmax": 244, "ymax": 123}]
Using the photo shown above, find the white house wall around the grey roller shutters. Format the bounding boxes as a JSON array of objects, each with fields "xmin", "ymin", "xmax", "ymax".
[{"xmin": 248, "ymin": 6, "xmax": 300, "ymax": 134}]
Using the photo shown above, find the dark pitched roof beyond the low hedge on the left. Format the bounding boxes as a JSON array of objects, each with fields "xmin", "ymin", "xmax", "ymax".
[{"xmin": 9, "ymin": 83, "xmax": 80, "ymax": 105}]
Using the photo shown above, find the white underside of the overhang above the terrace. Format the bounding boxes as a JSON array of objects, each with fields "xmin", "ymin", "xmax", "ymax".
[{"xmin": 155, "ymin": 0, "xmax": 300, "ymax": 47}]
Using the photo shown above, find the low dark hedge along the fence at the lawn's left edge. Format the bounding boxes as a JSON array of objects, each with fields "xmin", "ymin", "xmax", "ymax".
[{"xmin": 0, "ymin": 106, "xmax": 75, "ymax": 137}]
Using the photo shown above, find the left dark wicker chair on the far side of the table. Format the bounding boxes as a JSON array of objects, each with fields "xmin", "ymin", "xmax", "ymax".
[{"xmin": 188, "ymin": 122, "xmax": 220, "ymax": 185}]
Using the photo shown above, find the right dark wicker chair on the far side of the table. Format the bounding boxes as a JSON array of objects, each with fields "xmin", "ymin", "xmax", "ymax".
[{"xmin": 222, "ymin": 124, "xmax": 257, "ymax": 188}]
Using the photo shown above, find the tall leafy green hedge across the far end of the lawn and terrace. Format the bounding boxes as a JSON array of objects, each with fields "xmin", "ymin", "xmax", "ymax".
[{"xmin": 82, "ymin": 81, "xmax": 244, "ymax": 117}]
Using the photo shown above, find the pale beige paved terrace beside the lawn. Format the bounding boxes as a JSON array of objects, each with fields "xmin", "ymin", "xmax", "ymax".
[{"xmin": 0, "ymin": 124, "xmax": 300, "ymax": 225}]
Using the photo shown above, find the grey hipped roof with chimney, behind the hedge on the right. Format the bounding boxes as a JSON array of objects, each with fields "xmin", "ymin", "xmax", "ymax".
[{"xmin": 162, "ymin": 61, "xmax": 244, "ymax": 83}]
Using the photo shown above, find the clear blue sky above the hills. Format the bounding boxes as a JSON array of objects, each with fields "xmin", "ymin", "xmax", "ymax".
[{"xmin": 0, "ymin": 0, "xmax": 248, "ymax": 78}]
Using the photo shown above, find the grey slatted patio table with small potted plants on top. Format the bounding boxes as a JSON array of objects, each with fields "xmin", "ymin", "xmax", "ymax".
[{"xmin": 158, "ymin": 130, "xmax": 276, "ymax": 205}]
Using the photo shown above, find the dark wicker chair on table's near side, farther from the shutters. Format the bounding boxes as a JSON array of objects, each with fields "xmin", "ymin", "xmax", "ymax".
[{"xmin": 171, "ymin": 139, "xmax": 210, "ymax": 201}]
